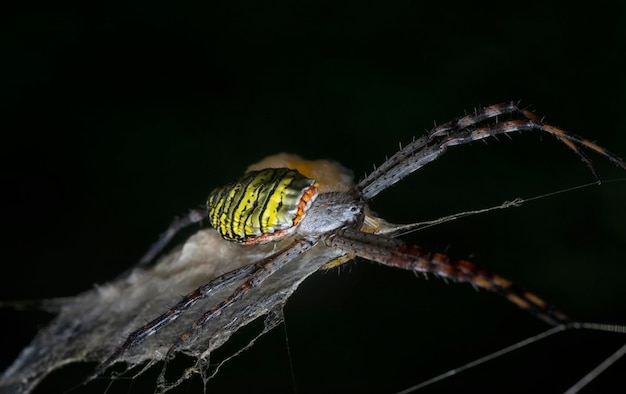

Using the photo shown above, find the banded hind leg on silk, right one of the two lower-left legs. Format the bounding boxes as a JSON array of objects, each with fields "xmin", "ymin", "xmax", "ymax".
[{"xmin": 165, "ymin": 238, "xmax": 317, "ymax": 360}]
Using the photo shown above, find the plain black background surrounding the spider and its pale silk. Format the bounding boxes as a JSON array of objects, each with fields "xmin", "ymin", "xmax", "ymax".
[{"xmin": 0, "ymin": 1, "xmax": 626, "ymax": 393}]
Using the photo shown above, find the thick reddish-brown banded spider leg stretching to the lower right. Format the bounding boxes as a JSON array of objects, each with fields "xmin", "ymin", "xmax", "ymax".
[{"xmin": 325, "ymin": 229, "xmax": 569, "ymax": 326}]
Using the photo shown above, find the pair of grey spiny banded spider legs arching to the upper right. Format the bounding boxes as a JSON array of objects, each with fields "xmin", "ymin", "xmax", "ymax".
[{"xmin": 357, "ymin": 102, "xmax": 626, "ymax": 200}]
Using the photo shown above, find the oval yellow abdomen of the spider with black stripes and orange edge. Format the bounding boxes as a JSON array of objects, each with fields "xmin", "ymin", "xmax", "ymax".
[{"xmin": 207, "ymin": 168, "xmax": 318, "ymax": 244}]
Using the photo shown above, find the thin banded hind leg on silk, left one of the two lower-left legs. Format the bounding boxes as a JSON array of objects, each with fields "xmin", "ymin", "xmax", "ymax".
[{"xmin": 93, "ymin": 255, "xmax": 258, "ymax": 376}]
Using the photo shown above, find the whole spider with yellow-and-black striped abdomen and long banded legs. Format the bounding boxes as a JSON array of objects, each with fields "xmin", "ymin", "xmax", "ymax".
[{"xmin": 91, "ymin": 102, "xmax": 626, "ymax": 388}]
